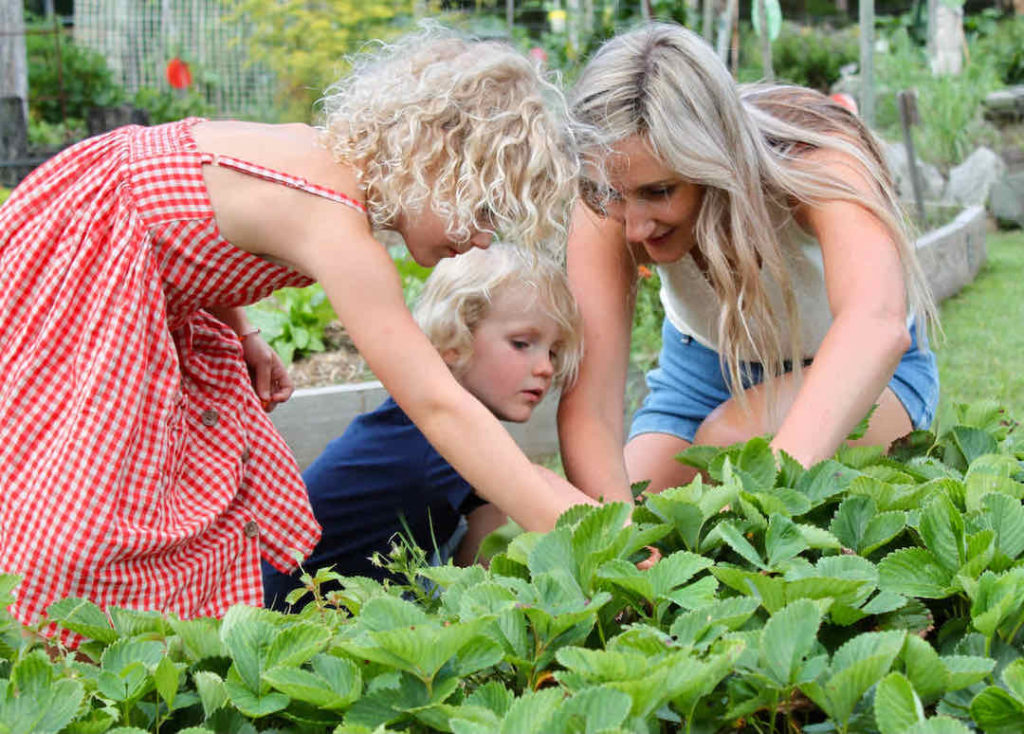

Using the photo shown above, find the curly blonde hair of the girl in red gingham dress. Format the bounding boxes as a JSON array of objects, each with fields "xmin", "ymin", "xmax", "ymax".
[{"xmin": 321, "ymin": 27, "xmax": 578, "ymax": 251}]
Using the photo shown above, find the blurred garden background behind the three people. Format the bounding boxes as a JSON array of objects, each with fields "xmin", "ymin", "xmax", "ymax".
[{"xmin": 0, "ymin": 0, "xmax": 1024, "ymax": 423}]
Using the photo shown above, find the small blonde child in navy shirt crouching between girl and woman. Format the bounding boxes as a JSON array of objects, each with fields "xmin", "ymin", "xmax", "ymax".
[{"xmin": 263, "ymin": 244, "xmax": 583, "ymax": 609}]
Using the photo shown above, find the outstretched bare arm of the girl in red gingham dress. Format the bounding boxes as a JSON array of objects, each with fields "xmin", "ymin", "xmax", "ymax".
[{"xmin": 291, "ymin": 226, "xmax": 595, "ymax": 530}]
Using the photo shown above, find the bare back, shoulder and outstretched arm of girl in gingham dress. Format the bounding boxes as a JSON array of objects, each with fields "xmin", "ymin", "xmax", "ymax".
[{"xmin": 195, "ymin": 123, "xmax": 593, "ymax": 530}]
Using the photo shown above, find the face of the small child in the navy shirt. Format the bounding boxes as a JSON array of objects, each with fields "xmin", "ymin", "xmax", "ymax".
[{"xmin": 445, "ymin": 287, "xmax": 562, "ymax": 423}]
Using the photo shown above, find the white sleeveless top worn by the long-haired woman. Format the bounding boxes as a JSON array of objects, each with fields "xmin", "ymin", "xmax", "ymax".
[{"xmin": 657, "ymin": 218, "xmax": 833, "ymax": 360}]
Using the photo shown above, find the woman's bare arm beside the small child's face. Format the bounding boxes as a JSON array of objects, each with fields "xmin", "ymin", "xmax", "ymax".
[{"xmin": 558, "ymin": 204, "xmax": 637, "ymax": 503}]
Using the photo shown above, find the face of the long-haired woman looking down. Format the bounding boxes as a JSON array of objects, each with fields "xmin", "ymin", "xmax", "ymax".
[{"xmin": 593, "ymin": 135, "xmax": 703, "ymax": 263}]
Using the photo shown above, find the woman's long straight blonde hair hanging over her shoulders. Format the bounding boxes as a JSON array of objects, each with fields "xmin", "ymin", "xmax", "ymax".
[{"xmin": 570, "ymin": 24, "xmax": 935, "ymax": 399}]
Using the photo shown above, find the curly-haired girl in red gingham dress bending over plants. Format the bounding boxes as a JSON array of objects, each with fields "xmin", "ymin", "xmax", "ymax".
[{"xmin": 0, "ymin": 31, "xmax": 589, "ymax": 643}]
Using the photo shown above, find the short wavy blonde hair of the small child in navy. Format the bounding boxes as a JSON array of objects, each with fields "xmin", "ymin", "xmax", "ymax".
[{"xmin": 413, "ymin": 243, "xmax": 583, "ymax": 387}]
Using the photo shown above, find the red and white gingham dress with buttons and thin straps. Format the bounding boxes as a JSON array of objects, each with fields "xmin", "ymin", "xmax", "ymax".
[{"xmin": 0, "ymin": 119, "xmax": 359, "ymax": 644}]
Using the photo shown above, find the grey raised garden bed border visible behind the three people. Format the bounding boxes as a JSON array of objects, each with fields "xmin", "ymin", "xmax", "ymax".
[{"xmin": 271, "ymin": 206, "xmax": 986, "ymax": 469}]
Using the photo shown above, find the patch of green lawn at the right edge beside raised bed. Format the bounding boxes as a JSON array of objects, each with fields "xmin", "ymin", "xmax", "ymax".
[{"xmin": 935, "ymin": 230, "xmax": 1024, "ymax": 421}]
